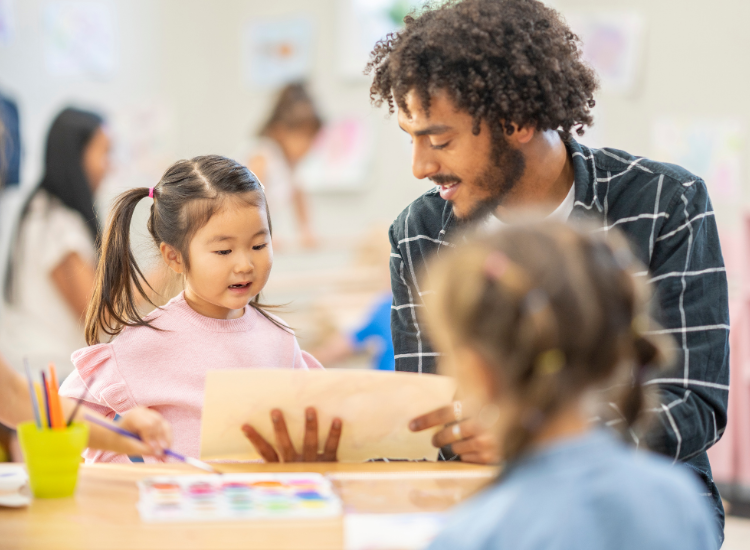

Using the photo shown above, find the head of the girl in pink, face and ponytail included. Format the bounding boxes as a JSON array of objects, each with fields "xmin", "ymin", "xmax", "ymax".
[{"xmin": 86, "ymin": 155, "xmax": 273, "ymax": 343}]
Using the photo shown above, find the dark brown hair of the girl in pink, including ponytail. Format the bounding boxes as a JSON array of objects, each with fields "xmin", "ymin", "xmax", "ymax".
[{"xmin": 85, "ymin": 155, "xmax": 289, "ymax": 345}]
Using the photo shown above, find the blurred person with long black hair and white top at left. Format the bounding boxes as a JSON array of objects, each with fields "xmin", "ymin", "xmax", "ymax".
[{"xmin": 0, "ymin": 108, "xmax": 110, "ymax": 376}]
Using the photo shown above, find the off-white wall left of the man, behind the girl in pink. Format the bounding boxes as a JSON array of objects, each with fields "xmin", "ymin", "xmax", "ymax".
[{"xmin": 0, "ymin": 0, "xmax": 428, "ymax": 245}]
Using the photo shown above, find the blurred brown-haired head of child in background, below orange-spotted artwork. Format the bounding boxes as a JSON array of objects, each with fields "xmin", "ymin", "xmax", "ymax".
[{"xmin": 259, "ymin": 83, "xmax": 323, "ymax": 164}]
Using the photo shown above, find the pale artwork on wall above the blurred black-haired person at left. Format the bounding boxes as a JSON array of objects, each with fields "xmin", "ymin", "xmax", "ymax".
[{"xmin": 44, "ymin": 0, "xmax": 116, "ymax": 78}]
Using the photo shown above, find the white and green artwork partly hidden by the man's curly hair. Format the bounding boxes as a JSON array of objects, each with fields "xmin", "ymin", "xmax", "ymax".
[{"xmin": 337, "ymin": 0, "xmax": 424, "ymax": 79}]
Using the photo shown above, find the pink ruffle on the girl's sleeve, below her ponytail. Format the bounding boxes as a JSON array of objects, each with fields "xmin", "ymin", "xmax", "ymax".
[{"xmin": 60, "ymin": 344, "xmax": 137, "ymax": 414}]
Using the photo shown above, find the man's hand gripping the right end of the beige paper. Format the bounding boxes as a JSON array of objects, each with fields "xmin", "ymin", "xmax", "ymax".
[{"xmin": 409, "ymin": 402, "xmax": 500, "ymax": 464}]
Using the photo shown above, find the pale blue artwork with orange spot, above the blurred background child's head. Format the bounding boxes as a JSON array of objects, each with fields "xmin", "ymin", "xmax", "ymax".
[{"xmin": 242, "ymin": 17, "xmax": 314, "ymax": 88}]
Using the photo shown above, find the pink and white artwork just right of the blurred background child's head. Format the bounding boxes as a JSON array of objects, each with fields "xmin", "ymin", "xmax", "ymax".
[{"xmin": 298, "ymin": 117, "xmax": 372, "ymax": 192}]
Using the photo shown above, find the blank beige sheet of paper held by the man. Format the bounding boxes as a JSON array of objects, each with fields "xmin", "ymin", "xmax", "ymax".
[{"xmin": 201, "ymin": 369, "xmax": 455, "ymax": 462}]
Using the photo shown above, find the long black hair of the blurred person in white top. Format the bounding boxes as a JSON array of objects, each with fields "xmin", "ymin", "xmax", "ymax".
[{"xmin": 5, "ymin": 107, "xmax": 104, "ymax": 302}]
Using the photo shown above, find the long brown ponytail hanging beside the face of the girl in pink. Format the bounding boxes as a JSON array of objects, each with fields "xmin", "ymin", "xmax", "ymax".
[{"xmin": 85, "ymin": 187, "xmax": 151, "ymax": 345}]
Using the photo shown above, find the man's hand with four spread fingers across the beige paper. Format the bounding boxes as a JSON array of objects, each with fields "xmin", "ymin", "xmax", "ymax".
[{"xmin": 242, "ymin": 407, "xmax": 341, "ymax": 462}]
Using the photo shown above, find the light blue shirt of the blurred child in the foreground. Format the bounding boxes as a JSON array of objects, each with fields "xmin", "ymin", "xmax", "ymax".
[{"xmin": 429, "ymin": 429, "xmax": 718, "ymax": 550}]
